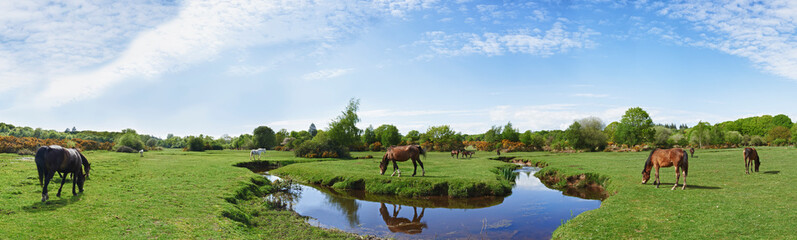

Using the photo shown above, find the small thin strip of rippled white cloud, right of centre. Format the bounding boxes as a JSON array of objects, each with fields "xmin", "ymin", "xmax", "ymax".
[{"xmin": 416, "ymin": 22, "xmax": 598, "ymax": 57}]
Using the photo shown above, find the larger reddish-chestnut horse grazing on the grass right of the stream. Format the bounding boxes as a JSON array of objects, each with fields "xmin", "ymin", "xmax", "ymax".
[{"xmin": 642, "ymin": 148, "xmax": 689, "ymax": 190}]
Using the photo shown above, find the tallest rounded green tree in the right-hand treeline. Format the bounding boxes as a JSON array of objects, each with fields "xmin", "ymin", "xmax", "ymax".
[{"xmin": 614, "ymin": 107, "xmax": 654, "ymax": 146}]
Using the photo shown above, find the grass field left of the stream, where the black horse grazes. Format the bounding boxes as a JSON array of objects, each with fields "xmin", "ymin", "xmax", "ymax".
[{"xmin": 0, "ymin": 150, "xmax": 356, "ymax": 239}]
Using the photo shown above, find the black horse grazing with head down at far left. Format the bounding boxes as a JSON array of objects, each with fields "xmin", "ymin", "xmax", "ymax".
[{"xmin": 36, "ymin": 145, "xmax": 91, "ymax": 202}]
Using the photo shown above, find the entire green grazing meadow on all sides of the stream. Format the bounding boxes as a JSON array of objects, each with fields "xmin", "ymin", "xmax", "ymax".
[{"xmin": 0, "ymin": 147, "xmax": 797, "ymax": 239}]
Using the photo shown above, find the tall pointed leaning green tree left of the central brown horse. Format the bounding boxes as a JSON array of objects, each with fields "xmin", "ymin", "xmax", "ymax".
[{"xmin": 326, "ymin": 98, "xmax": 361, "ymax": 146}]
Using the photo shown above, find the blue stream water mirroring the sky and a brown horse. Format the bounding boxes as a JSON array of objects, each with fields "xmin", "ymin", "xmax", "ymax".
[{"xmin": 262, "ymin": 167, "xmax": 600, "ymax": 239}]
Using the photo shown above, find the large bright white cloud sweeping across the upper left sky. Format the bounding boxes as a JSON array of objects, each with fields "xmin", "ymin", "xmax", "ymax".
[{"xmin": 0, "ymin": 0, "xmax": 435, "ymax": 107}]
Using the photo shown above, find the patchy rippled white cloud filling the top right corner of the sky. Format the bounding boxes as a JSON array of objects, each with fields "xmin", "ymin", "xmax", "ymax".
[{"xmin": 658, "ymin": 0, "xmax": 797, "ymax": 80}]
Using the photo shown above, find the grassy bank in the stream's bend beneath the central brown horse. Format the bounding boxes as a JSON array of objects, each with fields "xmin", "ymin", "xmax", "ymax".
[{"xmin": 271, "ymin": 152, "xmax": 515, "ymax": 197}]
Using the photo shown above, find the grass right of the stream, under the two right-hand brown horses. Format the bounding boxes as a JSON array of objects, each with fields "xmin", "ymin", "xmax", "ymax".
[{"xmin": 500, "ymin": 147, "xmax": 797, "ymax": 239}]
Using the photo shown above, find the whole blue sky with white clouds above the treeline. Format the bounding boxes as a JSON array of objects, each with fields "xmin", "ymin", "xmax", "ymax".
[{"xmin": 0, "ymin": 0, "xmax": 797, "ymax": 137}]
